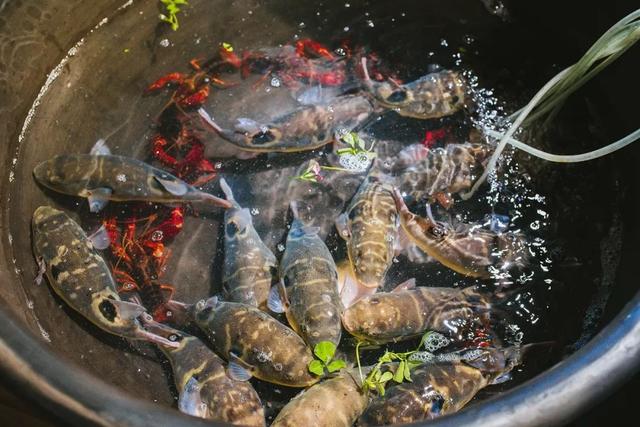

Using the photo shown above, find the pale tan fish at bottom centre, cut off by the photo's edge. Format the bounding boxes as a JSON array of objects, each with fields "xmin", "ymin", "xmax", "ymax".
[{"xmin": 271, "ymin": 370, "xmax": 369, "ymax": 427}]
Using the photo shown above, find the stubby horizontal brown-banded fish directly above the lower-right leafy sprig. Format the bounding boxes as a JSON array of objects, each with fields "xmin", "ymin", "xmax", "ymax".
[{"xmin": 342, "ymin": 282, "xmax": 491, "ymax": 344}]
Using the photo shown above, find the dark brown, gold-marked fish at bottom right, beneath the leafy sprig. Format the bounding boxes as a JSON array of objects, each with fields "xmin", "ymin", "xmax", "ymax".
[{"xmin": 357, "ymin": 346, "xmax": 521, "ymax": 427}]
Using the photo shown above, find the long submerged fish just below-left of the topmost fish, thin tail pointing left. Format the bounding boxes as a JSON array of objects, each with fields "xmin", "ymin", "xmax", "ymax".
[{"xmin": 198, "ymin": 95, "xmax": 374, "ymax": 153}]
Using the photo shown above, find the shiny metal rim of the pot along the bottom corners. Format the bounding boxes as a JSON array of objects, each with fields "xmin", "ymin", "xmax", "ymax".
[{"xmin": 0, "ymin": 292, "xmax": 640, "ymax": 427}]
